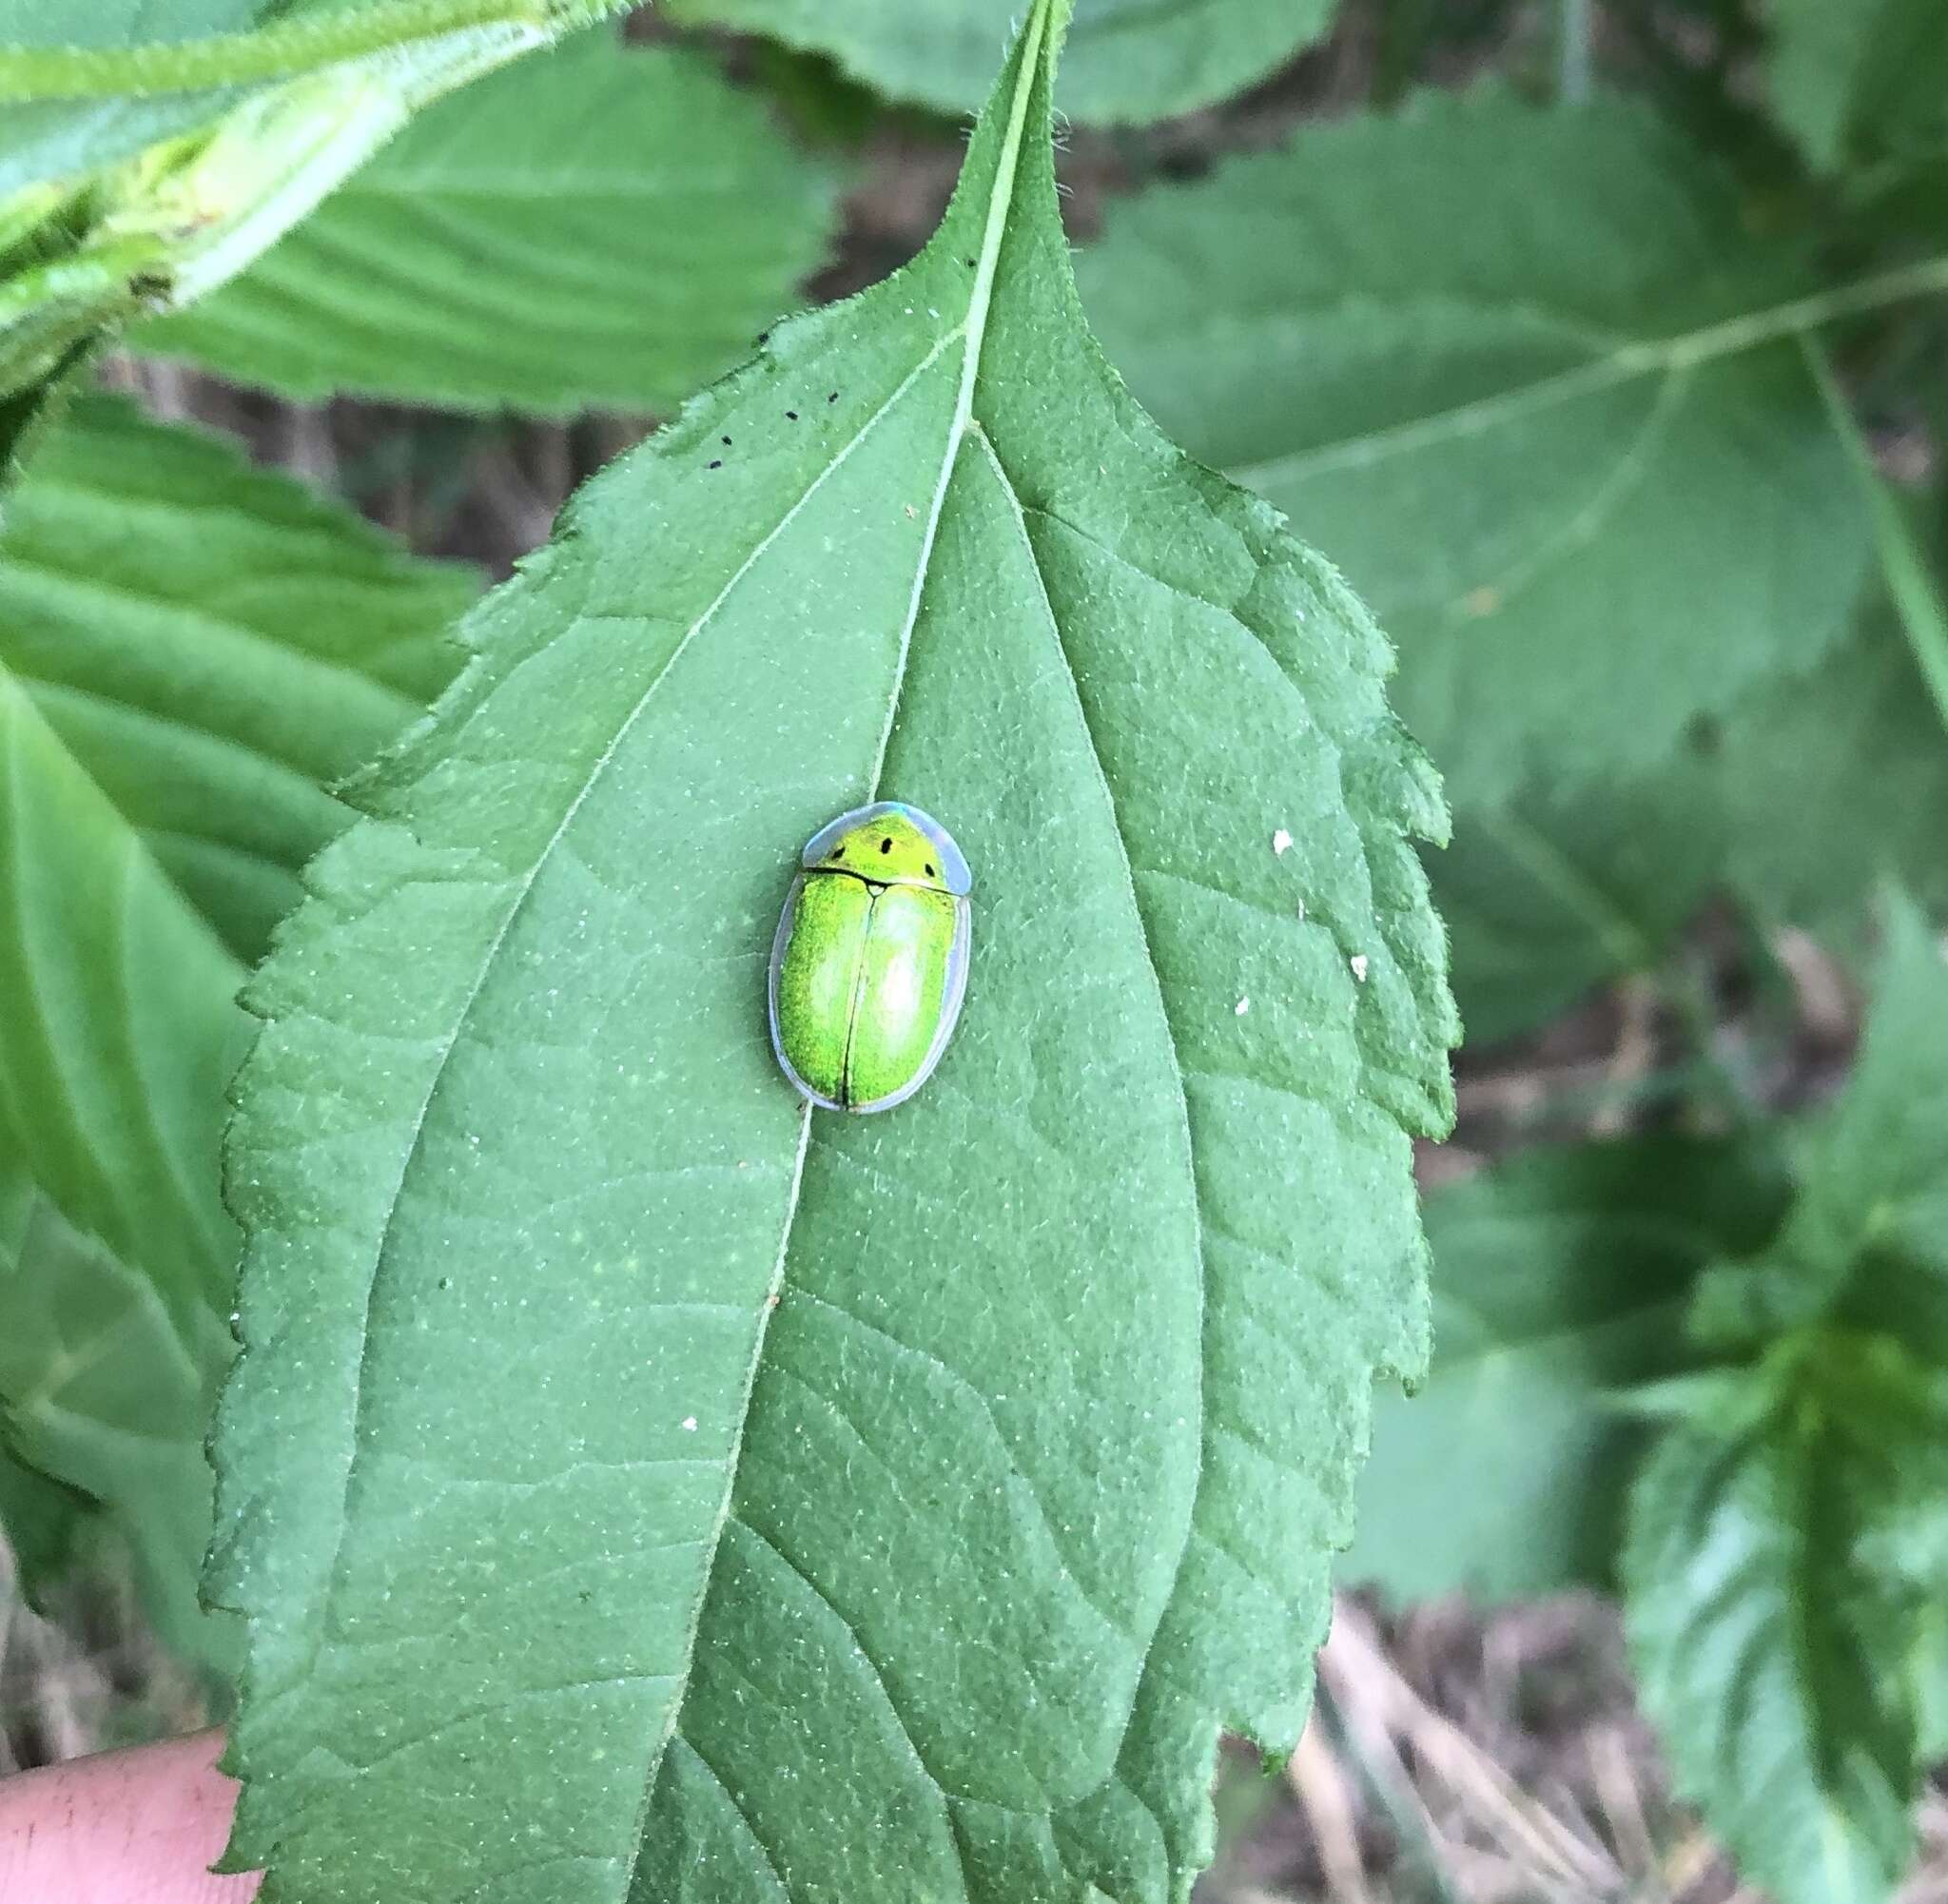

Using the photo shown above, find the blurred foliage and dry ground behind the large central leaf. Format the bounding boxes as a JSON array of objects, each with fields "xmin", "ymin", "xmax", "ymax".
[{"xmin": 0, "ymin": 0, "xmax": 1948, "ymax": 1904}]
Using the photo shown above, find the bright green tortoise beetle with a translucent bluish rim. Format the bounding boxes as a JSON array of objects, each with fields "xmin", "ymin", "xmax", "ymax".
[{"xmin": 771, "ymin": 800, "xmax": 974, "ymax": 1112}]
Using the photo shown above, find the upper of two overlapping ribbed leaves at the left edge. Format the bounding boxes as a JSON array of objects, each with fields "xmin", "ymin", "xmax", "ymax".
[{"xmin": 0, "ymin": 398, "xmax": 474, "ymax": 962}]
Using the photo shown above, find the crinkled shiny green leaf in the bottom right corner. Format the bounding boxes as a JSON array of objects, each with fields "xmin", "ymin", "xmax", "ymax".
[{"xmin": 1623, "ymin": 1339, "xmax": 1948, "ymax": 1904}]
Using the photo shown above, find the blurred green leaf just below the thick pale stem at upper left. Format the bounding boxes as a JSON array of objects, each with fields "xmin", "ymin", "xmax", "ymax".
[{"xmin": 136, "ymin": 35, "xmax": 834, "ymax": 415}]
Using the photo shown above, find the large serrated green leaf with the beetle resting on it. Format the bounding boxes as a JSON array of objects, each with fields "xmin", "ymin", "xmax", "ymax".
[{"xmin": 206, "ymin": 4, "xmax": 1453, "ymax": 1904}]
